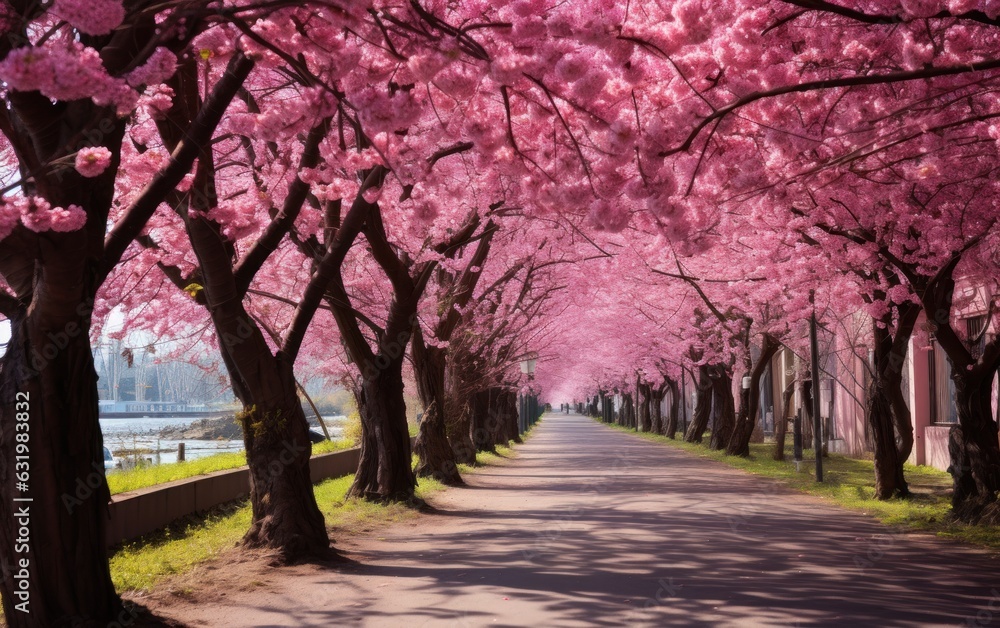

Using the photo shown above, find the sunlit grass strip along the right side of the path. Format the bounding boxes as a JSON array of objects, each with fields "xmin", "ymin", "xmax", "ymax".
[{"xmin": 596, "ymin": 425, "xmax": 1000, "ymax": 549}]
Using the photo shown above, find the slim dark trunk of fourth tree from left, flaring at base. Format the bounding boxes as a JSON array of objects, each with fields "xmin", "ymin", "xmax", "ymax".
[{"xmin": 412, "ymin": 334, "xmax": 464, "ymax": 486}]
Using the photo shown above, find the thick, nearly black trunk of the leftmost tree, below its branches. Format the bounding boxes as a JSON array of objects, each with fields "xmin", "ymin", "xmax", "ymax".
[{"xmin": 0, "ymin": 304, "xmax": 128, "ymax": 626}]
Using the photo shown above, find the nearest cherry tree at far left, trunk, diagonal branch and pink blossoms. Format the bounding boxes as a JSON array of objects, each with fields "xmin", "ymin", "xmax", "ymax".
[{"xmin": 0, "ymin": 1, "xmax": 266, "ymax": 626}]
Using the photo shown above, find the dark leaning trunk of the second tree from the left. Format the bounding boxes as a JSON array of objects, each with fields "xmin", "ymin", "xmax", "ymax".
[{"xmin": 185, "ymin": 209, "xmax": 330, "ymax": 561}]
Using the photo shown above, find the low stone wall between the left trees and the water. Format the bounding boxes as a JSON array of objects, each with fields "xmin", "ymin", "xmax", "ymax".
[{"xmin": 107, "ymin": 441, "xmax": 412, "ymax": 545}]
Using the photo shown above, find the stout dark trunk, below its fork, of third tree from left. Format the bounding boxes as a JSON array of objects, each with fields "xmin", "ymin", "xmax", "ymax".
[{"xmin": 348, "ymin": 353, "xmax": 417, "ymax": 502}]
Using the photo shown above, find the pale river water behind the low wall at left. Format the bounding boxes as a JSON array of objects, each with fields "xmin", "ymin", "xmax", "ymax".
[{"xmin": 101, "ymin": 416, "xmax": 346, "ymax": 464}]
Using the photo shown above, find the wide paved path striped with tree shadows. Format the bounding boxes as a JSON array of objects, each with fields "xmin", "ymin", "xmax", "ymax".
[{"xmin": 148, "ymin": 414, "xmax": 1000, "ymax": 628}]
